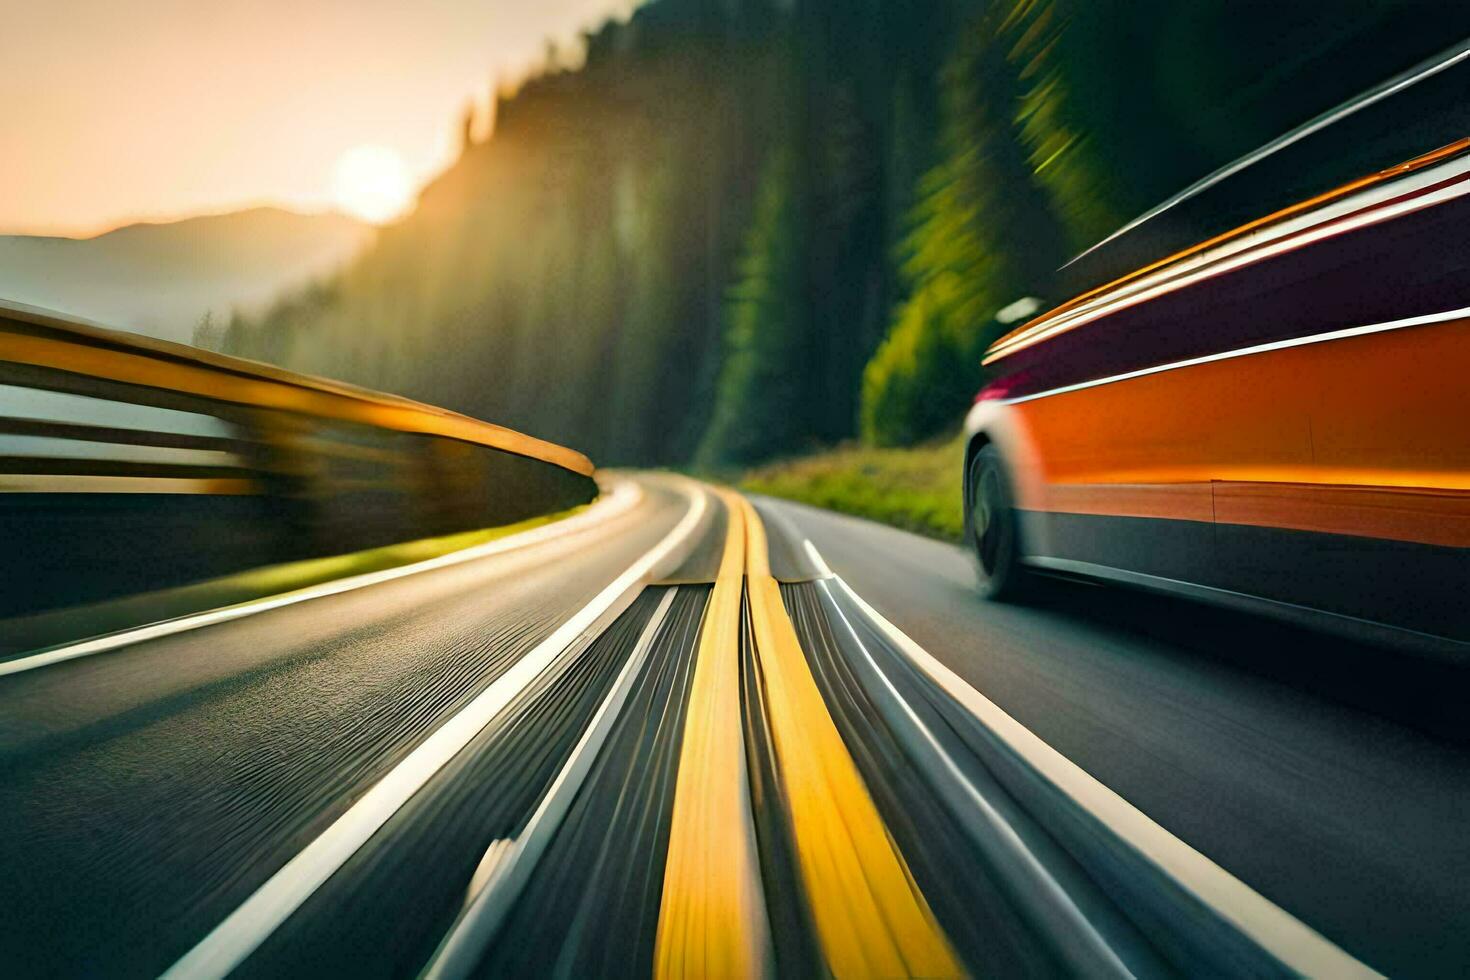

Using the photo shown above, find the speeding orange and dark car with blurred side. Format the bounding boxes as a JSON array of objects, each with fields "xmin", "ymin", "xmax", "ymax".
[{"xmin": 964, "ymin": 51, "xmax": 1470, "ymax": 657}]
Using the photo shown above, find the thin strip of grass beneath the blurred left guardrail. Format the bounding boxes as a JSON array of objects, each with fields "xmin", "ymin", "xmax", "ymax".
[{"xmin": 0, "ymin": 504, "xmax": 588, "ymax": 658}]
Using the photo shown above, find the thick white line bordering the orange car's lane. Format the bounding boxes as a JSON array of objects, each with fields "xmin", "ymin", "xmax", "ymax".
[{"xmin": 813, "ymin": 558, "xmax": 1382, "ymax": 977}]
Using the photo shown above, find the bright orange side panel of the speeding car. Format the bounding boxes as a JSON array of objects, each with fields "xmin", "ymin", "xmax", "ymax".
[{"xmin": 1023, "ymin": 313, "xmax": 1470, "ymax": 493}]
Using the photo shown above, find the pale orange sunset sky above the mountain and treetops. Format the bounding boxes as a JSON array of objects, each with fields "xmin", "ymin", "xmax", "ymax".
[{"xmin": 0, "ymin": 0, "xmax": 629, "ymax": 237}]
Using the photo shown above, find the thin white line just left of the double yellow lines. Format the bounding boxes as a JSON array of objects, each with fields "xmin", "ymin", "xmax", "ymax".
[{"xmin": 423, "ymin": 588, "xmax": 679, "ymax": 980}]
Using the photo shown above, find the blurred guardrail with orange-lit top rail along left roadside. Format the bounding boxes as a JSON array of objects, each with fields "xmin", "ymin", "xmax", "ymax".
[{"xmin": 0, "ymin": 301, "xmax": 597, "ymax": 617}]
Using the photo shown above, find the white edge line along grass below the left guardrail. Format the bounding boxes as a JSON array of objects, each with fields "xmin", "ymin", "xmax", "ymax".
[{"xmin": 0, "ymin": 479, "xmax": 644, "ymax": 677}]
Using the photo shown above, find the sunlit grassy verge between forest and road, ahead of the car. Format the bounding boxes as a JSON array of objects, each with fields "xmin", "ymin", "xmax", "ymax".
[{"xmin": 739, "ymin": 433, "xmax": 964, "ymax": 541}]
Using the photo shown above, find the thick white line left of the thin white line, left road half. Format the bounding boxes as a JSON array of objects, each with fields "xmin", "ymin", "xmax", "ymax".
[{"xmin": 163, "ymin": 480, "xmax": 707, "ymax": 979}]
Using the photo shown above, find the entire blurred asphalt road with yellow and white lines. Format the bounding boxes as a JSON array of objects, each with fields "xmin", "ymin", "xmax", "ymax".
[{"xmin": 0, "ymin": 476, "xmax": 1470, "ymax": 976}]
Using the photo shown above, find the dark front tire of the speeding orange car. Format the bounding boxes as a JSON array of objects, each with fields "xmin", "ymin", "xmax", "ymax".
[{"xmin": 964, "ymin": 444, "xmax": 1035, "ymax": 602}]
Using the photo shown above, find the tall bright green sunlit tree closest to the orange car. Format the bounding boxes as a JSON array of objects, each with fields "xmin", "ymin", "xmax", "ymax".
[{"xmin": 861, "ymin": 3, "xmax": 1067, "ymax": 445}]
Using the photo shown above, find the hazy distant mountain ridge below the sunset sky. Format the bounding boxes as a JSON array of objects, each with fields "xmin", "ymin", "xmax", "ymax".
[{"xmin": 0, "ymin": 207, "xmax": 376, "ymax": 342}]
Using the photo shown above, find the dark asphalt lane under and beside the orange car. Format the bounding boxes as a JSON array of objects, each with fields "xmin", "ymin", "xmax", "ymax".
[{"xmin": 760, "ymin": 501, "xmax": 1470, "ymax": 976}]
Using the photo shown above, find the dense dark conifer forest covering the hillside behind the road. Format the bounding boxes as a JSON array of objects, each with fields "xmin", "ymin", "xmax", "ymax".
[{"xmin": 213, "ymin": 0, "xmax": 1454, "ymax": 466}]
